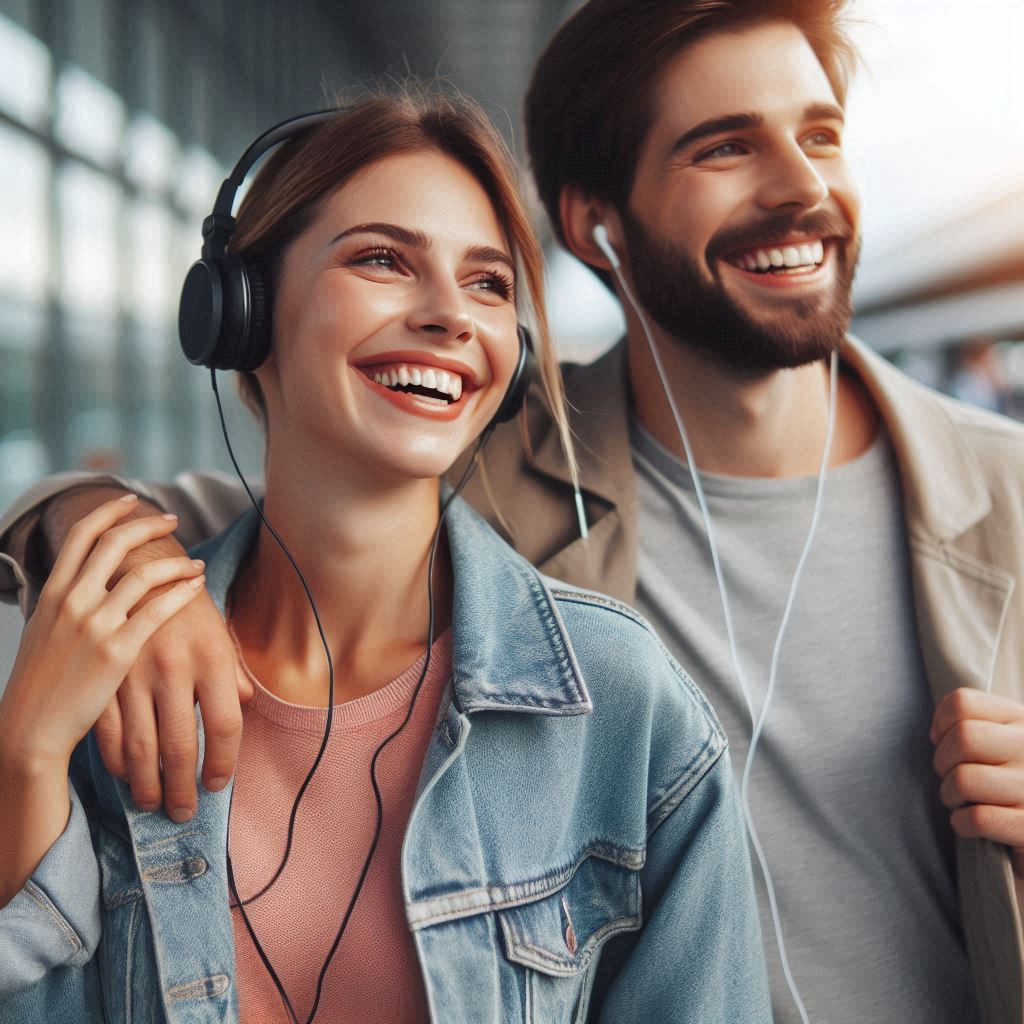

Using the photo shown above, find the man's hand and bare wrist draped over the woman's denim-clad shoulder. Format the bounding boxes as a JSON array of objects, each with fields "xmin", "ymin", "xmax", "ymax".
[{"xmin": 43, "ymin": 486, "xmax": 254, "ymax": 821}]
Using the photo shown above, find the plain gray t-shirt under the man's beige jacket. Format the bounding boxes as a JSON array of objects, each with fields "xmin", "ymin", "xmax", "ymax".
[{"xmin": 632, "ymin": 422, "xmax": 979, "ymax": 1024}]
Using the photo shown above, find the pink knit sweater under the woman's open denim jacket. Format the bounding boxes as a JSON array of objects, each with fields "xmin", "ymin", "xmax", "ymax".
[{"xmin": 230, "ymin": 633, "xmax": 452, "ymax": 1024}]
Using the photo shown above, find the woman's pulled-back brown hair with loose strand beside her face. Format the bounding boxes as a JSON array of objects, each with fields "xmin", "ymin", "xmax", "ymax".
[{"xmin": 230, "ymin": 83, "xmax": 577, "ymax": 495}]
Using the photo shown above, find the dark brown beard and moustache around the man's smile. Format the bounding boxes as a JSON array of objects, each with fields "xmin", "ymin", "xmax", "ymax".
[{"xmin": 621, "ymin": 203, "xmax": 860, "ymax": 376}]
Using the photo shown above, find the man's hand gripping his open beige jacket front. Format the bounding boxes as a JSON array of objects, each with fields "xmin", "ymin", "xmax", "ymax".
[{"xmin": 930, "ymin": 688, "xmax": 1024, "ymax": 880}]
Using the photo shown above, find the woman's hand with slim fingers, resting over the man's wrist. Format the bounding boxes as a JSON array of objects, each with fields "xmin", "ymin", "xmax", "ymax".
[{"xmin": 0, "ymin": 495, "xmax": 204, "ymax": 772}]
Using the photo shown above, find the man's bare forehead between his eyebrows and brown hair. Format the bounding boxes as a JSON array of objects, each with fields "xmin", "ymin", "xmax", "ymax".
[{"xmin": 652, "ymin": 22, "xmax": 837, "ymax": 133}]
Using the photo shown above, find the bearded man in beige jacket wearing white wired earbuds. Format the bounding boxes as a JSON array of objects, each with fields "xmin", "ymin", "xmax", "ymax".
[{"xmin": 7, "ymin": 0, "xmax": 1024, "ymax": 1024}]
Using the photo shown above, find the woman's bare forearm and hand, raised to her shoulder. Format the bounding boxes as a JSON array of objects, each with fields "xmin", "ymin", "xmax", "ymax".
[{"xmin": 0, "ymin": 496, "xmax": 203, "ymax": 907}]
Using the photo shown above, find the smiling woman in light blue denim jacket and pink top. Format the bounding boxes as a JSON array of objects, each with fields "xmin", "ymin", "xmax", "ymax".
[{"xmin": 0, "ymin": 94, "xmax": 770, "ymax": 1024}]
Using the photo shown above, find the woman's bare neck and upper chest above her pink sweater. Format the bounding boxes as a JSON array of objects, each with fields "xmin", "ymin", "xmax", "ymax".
[{"xmin": 230, "ymin": 459, "xmax": 452, "ymax": 707}]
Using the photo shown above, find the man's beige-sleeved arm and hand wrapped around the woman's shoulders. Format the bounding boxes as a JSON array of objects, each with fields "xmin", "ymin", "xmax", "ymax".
[{"xmin": 0, "ymin": 473, "xmax": 252, "ymax": 820}]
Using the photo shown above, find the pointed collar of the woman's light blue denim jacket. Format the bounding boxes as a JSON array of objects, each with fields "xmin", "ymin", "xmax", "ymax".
[{"xmin": 193, "ymin": 485, "xmax": 592, "ymax": 715}]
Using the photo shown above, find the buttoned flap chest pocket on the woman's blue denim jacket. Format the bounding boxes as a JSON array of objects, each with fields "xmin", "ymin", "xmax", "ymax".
[{"xmin": 498, "ymin": 857, "xmax": 642, "ymax": 1024}]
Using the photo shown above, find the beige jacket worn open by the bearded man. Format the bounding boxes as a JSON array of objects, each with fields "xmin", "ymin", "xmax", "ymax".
[{"xmin": 0, "ymin": 340, "xmax": 1024, "ymax": 1024}]
